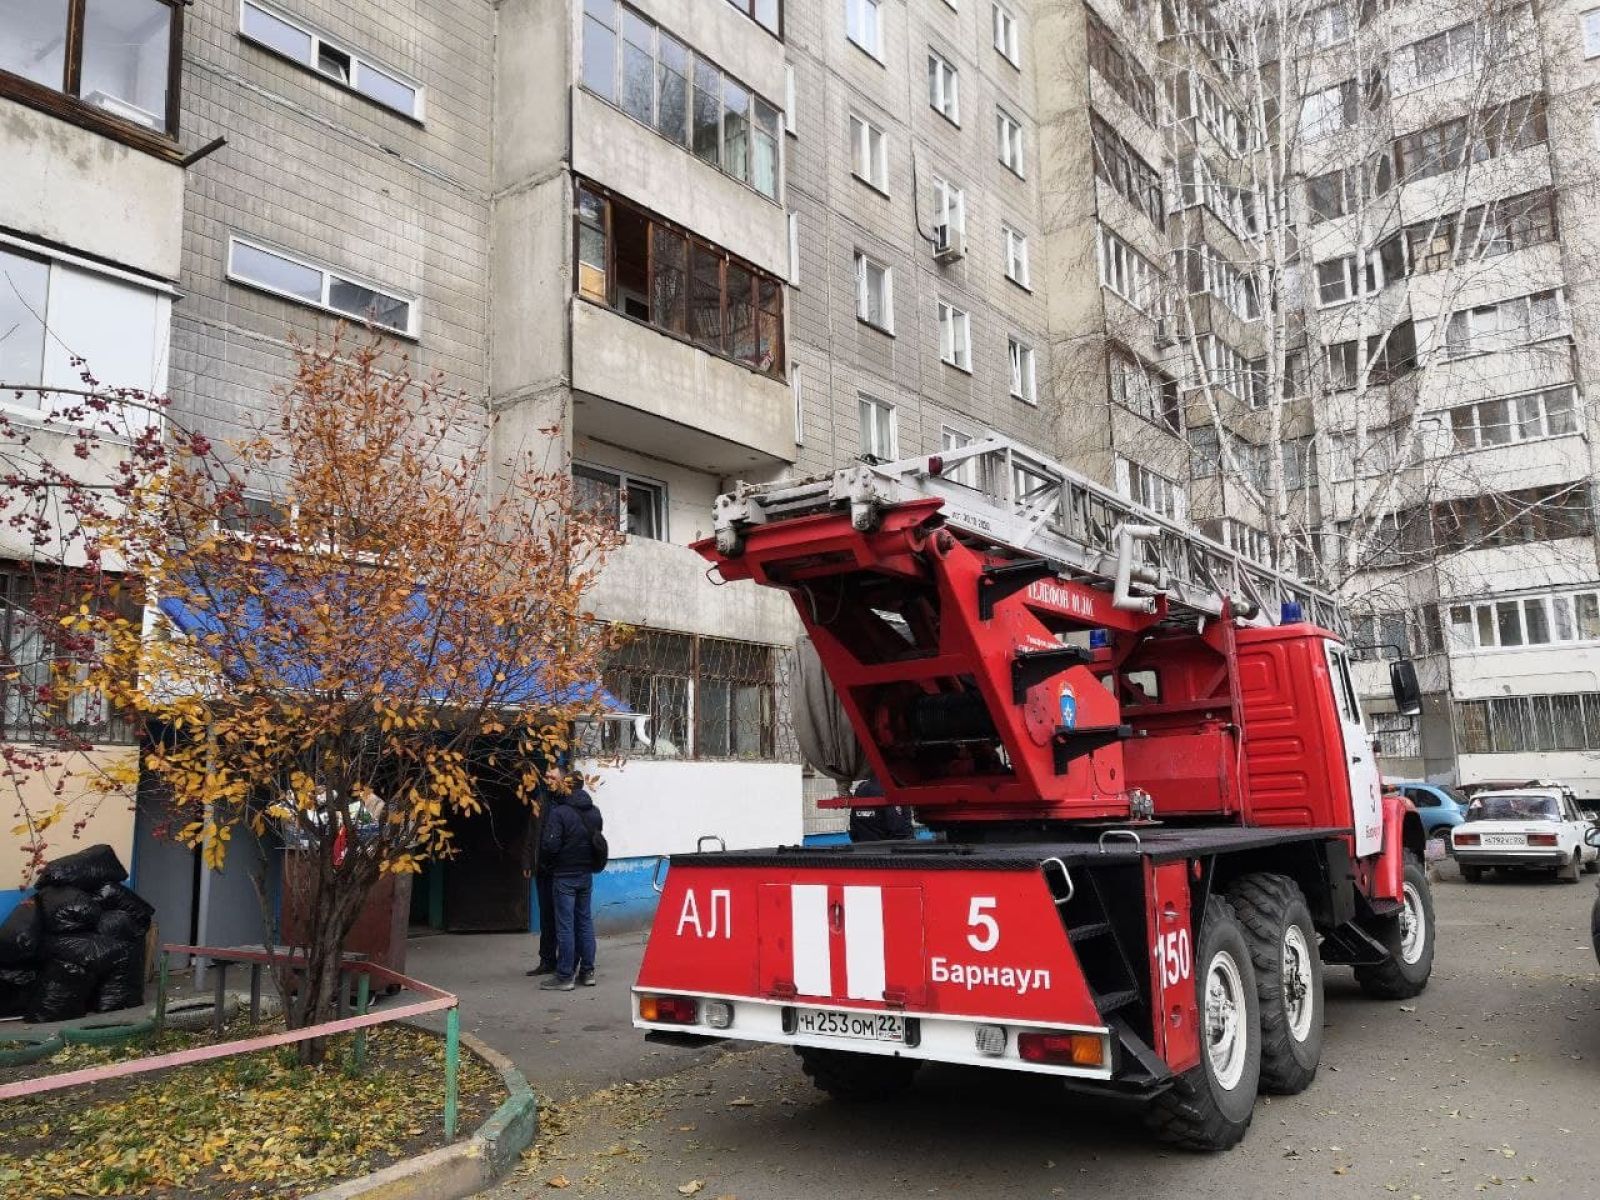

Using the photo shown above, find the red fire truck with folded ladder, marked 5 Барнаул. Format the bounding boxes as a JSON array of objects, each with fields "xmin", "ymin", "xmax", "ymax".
[{"xmin": 634, "ymin": 438, "xmax": 1434, "ymax": 1150}]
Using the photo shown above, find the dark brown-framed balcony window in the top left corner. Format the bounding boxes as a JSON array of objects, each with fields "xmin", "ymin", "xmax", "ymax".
[{"xmin": 0, "ymin": 0, "xmax": 182, "ymax": 136}]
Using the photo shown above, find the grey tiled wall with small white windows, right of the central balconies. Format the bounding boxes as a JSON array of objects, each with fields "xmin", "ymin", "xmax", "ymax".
[{"xmin": 786, "ymin": 0, "xmax": 1056, "ymax": 472}]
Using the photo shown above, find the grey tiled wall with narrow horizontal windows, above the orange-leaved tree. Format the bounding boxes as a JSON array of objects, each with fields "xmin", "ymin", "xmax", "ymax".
[{"xmin": 171, "ymin": 0, "xmax": 494, "ymax": 448}]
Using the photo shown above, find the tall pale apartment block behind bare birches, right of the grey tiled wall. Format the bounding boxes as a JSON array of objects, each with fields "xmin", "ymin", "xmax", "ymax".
[{"xmin": 1038, "ymin": 0, "xmax": 1600, "ymax": 794}]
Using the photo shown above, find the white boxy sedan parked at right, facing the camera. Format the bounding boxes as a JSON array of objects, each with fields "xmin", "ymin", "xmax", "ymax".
[{"xmin": 1450, "ymin": 787, "xmax": 1600, "ymax": 883}]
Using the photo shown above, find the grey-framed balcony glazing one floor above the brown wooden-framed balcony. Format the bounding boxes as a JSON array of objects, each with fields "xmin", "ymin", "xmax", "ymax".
[{"xmin": 582, "ymin": 0, "xmax": 779, "ymax": 200}]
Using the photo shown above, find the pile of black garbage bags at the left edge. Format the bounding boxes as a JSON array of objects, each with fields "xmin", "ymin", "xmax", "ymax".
[{"xmin": 0, "ymin": 846, "xmax": 155, "ymax": 1021}]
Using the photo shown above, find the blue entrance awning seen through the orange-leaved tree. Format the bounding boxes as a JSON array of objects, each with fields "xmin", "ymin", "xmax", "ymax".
[{"xmin": 157, "ymin": 584, "xmax": 640, "ymax": 718}]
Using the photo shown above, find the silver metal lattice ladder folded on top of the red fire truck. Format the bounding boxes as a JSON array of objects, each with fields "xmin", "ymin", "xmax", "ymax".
[{"xmin": 715, "ymin": 437, "xmax": 1346, "ymax": 632}]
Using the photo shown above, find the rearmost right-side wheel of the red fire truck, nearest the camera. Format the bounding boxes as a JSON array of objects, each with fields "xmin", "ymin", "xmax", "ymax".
[{"xmin": 1144, "ymin": 896, "xmax": 1261, "ymax": 1150}]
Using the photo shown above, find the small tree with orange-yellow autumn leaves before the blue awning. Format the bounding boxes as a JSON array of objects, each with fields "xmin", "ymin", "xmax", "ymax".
[{"xmin": 48, "ymin": 334, "xmax": 621, "ymax": 1058}]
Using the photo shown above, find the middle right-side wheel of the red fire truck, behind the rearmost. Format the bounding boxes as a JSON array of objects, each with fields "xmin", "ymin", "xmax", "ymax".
[{"xmin": 1227, "ymin": 874, "xmax": 1323, "ymax": 1096}]
